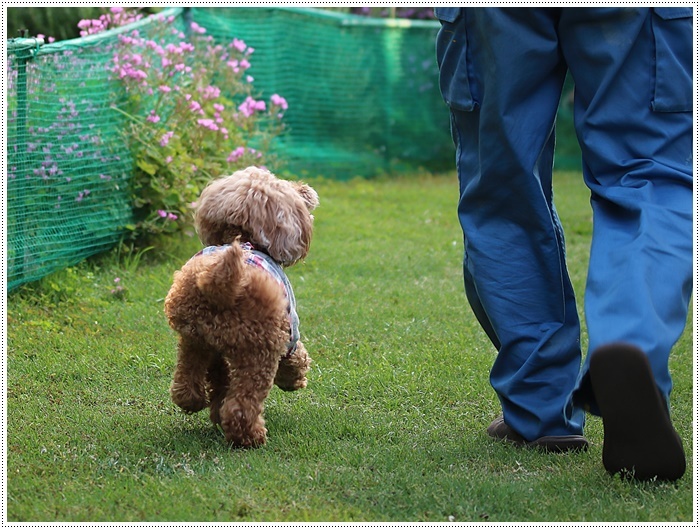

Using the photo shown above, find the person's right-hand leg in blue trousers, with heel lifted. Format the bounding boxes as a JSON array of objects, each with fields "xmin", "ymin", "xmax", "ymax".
[{"xmin": 560, "ymin": 8, "xmax": 693, "ymax": 474}]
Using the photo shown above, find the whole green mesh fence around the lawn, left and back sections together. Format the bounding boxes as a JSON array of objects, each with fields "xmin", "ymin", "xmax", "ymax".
[{"xmin": 6, "ymin": 7, "xmax": 580, "ymax": 290}]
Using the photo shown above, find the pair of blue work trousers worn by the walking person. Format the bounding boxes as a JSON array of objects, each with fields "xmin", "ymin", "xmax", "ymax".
[{"xmin": 435, "ymin": 7, "xmax": 693, "ymax": 440}]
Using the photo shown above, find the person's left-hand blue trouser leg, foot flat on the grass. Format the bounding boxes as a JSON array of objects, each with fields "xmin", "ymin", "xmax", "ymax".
[{"xmin": 437, "ymin": 8, "xmax": 583, "ymax": 441}]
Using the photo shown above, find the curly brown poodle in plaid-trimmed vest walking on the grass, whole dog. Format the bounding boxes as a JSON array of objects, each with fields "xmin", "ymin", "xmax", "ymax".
[{"xmin": 165, "ymin": 167, "xmax": 318, "ymax": 447}]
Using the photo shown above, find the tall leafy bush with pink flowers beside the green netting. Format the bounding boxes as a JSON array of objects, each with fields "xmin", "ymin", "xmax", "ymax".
[{"xmin": 80, "ymin": 8, "xmax": 288, "ymax": 238}]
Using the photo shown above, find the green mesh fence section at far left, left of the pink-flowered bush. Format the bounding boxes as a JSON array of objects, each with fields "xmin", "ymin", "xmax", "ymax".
[{"xmin": 6, "ymin": 10, "xmax": 186, "ymax": 290}]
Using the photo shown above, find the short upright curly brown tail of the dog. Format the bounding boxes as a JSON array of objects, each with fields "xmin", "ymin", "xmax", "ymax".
[{"xmin": 196, "ymin": 240, "xmax": 245, "ymax": 307}]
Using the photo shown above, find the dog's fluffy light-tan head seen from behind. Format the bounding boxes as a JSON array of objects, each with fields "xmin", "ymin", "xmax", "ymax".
[{"xmin": 195, "ymin": 167, "xmax": 318, "ymax": 266}]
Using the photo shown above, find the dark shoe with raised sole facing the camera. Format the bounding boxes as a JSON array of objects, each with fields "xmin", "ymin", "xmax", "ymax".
[{"xmin": 590, "ymin": 344, "xmax": 685, "ymax": 481}]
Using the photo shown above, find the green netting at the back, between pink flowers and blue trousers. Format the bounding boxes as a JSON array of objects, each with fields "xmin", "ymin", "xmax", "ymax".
[{"xmin": 192, "ymin": 8, "xmax": 454, "ymax": 178}]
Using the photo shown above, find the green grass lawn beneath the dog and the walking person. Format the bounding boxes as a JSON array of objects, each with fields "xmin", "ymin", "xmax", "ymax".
[{"xmin": 6, "ymin": 173, "xmax": 694, "ymax": 522}]
